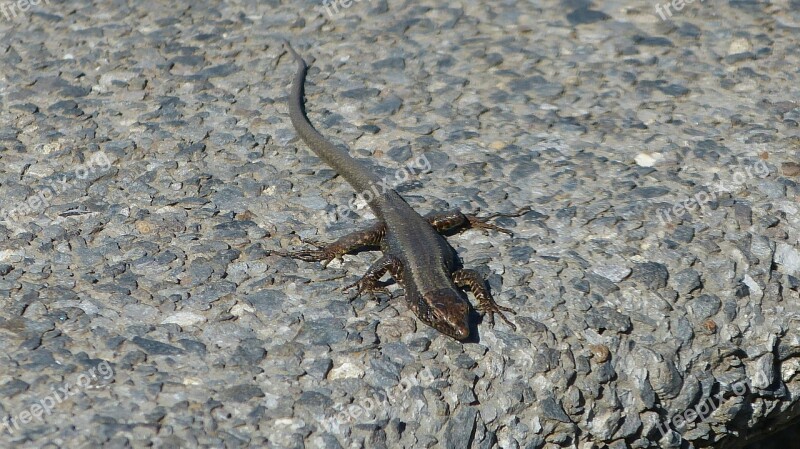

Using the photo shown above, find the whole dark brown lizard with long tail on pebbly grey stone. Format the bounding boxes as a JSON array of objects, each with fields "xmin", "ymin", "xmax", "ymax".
[{"xmin": 277, "ymin": 42, "xmax": 530, "ymax": 341}]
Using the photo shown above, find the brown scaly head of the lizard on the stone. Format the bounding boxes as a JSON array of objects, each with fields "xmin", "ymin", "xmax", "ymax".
[{"xmin": 420, "ymin": 288, "xmax": 469, "ymax": 340}]
